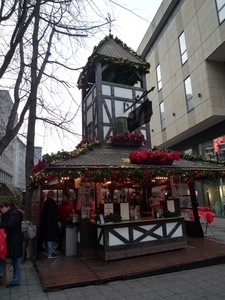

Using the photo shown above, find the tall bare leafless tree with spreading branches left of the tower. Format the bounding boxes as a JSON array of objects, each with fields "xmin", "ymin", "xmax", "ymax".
[{"xmin": 0, "ymin": 0, "xmax": 114, "ymax": 217}]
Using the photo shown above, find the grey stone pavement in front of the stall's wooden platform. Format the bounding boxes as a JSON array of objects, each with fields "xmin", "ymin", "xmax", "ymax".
[{"xmin": 0, "ymin": 218, "xmax": 225, "ymax": 300}]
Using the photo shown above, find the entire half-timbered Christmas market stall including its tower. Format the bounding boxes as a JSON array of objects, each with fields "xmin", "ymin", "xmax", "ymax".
[{"xmin": 28, "ymin": 34, "xmax": 225, "ymax": 261}]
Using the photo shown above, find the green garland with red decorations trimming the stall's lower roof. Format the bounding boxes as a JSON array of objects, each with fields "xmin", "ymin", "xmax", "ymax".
[{"xmin": 27, "ymin": 144, "xmax": 225, "ymax": 189}]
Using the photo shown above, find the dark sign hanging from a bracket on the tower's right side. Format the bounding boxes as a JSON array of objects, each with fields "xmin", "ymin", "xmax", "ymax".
[{"xmin": 127, "ymin": 99, "xmax": 152, "ymax": 132}]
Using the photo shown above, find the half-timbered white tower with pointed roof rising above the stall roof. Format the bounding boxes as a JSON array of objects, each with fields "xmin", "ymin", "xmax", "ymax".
[{"xmin": 78, "ymin": 34, "xmax": 151, "ymax": 147}]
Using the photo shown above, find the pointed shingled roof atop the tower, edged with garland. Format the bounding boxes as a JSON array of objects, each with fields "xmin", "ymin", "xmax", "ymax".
[{"xmin": 78, "ymin": 34, "xmax": 150, "ymax": 88}]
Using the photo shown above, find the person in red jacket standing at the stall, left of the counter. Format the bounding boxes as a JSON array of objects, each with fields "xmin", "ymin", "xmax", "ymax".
[{"xmin": 56, "ymin": 195, "xmax": 73, "ymax": 250}]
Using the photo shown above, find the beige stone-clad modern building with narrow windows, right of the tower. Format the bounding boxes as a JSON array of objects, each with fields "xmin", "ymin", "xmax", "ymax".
[{"xmin": 137, "ymin": 0, "xmax": 225, "ymax": 214}]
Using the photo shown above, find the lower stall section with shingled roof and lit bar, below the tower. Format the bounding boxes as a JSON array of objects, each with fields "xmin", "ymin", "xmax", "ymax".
[{"xmin": 30, "ymin": 142, "xmax": 225, "ymax": 260}]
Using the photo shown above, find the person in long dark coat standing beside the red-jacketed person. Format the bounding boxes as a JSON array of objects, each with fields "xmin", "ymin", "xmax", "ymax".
[{"xmin": 42, "ymin": 190, "xmax": 61, "ymax": 258}]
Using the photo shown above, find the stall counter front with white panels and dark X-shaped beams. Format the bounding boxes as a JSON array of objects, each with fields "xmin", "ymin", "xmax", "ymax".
[{"xmin": 91, "ymin": 217, "xmax": 187, "ymax": 261}]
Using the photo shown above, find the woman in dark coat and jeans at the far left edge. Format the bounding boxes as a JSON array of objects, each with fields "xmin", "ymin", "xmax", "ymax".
[{"xmin": 0, "ymin": 202, "xmax": 23, "ymax": 286}]
